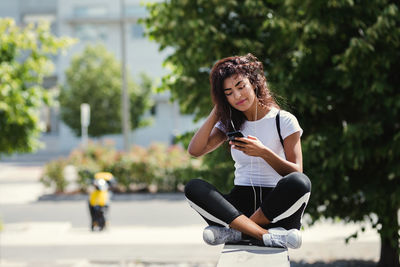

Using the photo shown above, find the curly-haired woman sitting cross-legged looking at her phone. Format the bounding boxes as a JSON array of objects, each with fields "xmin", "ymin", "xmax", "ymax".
[{"xmin": 185, "ymin": 54, "xmax": 311, "ymax": 248}]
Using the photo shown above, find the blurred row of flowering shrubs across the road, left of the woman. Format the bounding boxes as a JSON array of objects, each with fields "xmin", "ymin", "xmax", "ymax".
[{"xmin": 42, "ymin": 142, "xmax": 202, "ymax": 192}]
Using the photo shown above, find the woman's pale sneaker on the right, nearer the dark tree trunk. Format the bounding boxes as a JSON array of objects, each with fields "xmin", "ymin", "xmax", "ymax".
[{"xmin": 263, "ymin": 227, "xmax": 302, "ymax": 248}]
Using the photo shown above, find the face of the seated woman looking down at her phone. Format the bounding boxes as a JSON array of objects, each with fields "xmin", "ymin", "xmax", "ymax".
[{"xmin": 224, "ymin": 74, "xmax": 256, "ymax": 112}]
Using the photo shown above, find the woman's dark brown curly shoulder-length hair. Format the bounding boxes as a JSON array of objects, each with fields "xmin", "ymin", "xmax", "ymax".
[{"xmin": 210, "ymin": 53, "xmax": 279, "ymax": 131}]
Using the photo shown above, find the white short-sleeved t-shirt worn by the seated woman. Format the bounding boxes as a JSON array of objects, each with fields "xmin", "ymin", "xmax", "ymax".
[{"xmin": 215, "ymin": 108, "xmax": 303, "ymax": 187}]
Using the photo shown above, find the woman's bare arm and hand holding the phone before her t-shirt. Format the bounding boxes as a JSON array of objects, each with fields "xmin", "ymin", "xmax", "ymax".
[{"xmin": 230, "ymin": 132, "xmax": 303, "ymax": 176}]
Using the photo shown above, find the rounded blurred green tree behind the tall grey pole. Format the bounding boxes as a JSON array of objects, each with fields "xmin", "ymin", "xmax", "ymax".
[{"xmin": 59, "ymin": 45, "xmax": 152, "ymax": 137}]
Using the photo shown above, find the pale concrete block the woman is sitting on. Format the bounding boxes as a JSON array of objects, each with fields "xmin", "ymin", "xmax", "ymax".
[{"xmin": 217, "ymin": 242, "xmax": 290, "ymax": 267}]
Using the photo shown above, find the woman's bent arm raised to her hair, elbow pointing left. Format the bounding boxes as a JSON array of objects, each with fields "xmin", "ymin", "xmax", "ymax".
[{"xmin": 188, "ymin": 107, "xmax": 226, "ymax": 157}]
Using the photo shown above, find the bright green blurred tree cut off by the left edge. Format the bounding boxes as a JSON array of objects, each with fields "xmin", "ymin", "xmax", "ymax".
[{"xmin": 0, "ymin": 18, "xmax": 74, "ymax": 154}]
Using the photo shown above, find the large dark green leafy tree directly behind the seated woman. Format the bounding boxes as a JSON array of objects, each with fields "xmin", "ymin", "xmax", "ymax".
[{"xmin": 145, "ymin": 0, "xmax": 400, "ymax": 266}]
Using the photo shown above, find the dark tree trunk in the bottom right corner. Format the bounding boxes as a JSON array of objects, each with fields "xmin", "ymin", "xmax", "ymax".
[{"xmin": 378, "ymin": 209, "xmax": 400, "ymax": 267}]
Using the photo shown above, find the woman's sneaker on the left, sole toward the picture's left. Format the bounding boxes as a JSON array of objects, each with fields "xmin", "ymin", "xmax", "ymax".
[{"xmin": 203, "ymin": 226, "xmax": 242, "ymax": 246}]
